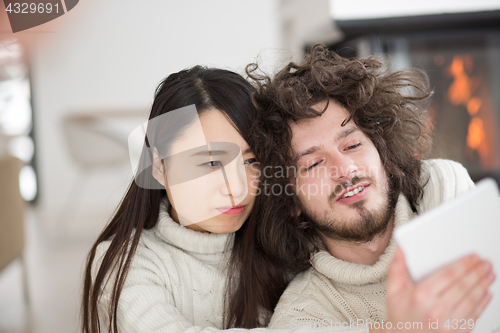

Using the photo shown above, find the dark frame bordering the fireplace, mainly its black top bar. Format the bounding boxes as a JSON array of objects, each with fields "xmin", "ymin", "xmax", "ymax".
[{"xmin": 329, "ymin": 10, "xmax": 500, "ymax": 185}]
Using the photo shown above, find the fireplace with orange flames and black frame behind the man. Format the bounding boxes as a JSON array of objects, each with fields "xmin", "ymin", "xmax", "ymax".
[{"xmin": 330, "ymin": 11, "xmax": 500, "ymax": 184}]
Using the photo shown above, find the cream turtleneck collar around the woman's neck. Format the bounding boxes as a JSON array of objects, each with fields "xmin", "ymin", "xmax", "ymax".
[{"xmin": 155, "ymin": 198, "xmax": 234, "ymax": 254}]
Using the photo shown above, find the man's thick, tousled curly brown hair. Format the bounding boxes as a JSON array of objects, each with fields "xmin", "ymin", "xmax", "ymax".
[{"xmin": 247, "ymin": 45, "xmax": 431, "ymax": 270}]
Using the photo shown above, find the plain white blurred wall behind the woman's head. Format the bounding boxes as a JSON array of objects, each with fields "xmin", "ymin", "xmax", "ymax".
[{"xmin": 31, "ymin": 0, "xmax": 281, "ymax": 230}]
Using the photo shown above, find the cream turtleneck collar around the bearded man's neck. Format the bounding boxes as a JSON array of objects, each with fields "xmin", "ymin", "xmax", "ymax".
[{"xmin": 311, "ymin": 194, "xmax": 413, "ymax": 285}]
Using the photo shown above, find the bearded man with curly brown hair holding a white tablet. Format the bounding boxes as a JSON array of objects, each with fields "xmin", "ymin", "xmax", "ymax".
[{"xmin": 250, "ymin": 46, "xmax": 495, "ymax": 332}]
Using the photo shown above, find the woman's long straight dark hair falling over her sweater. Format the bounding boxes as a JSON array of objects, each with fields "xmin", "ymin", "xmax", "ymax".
[{"xmin": 82, "ymin": 66, "xmax": 286, "ymax": 333}]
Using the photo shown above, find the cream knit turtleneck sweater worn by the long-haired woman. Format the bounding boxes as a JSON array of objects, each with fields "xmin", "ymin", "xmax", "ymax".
[{"xmin": 92, "ymin": 201, "xmax": 361, "ymax": 333}]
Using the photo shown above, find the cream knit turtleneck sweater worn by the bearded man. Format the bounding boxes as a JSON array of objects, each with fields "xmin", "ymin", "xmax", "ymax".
[{"xmin": 269, "ymin": 160, "xmax": 474, "ymax": 332}]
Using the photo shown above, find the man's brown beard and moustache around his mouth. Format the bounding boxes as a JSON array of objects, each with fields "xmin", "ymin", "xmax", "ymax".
[{"xmin": 302, "ymin": 177, "xmax": 394, "ymax": 243}]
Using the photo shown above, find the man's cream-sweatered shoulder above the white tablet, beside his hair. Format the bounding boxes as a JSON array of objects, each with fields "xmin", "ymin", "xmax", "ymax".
[{"xmin": 419, "ymin": 159, "xmax": 474, "ymax": 212}]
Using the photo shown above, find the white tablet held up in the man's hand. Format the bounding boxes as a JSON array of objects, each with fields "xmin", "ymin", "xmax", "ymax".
[{"xmin": 394, "ymin": 179, "xmax": 500, "ymax": 333}]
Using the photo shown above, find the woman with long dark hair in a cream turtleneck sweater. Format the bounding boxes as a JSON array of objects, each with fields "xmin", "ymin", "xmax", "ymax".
[{"xmin": 82, "ymin": 66, "xmax": 287, "ymax": 333}]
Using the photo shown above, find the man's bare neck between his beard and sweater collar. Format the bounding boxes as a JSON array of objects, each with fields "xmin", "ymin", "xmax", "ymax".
[{"xmin": 320, "ymin": 216, "xmax": 394, "ymax": 265}]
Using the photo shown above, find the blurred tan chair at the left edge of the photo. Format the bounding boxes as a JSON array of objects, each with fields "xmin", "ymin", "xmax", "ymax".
[{"xmin": 0, "ymin": 155, "xmax": 29, "ymax": 305}]
